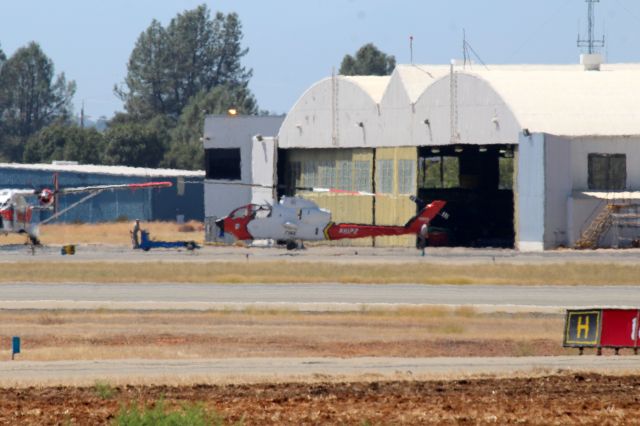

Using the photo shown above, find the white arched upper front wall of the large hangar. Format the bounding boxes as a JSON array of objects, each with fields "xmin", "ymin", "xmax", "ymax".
[{"xmin": 278, "ymin": 72, "xmax": 520, "ymax": 148}]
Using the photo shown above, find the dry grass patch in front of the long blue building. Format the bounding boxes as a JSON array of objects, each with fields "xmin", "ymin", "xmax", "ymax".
[{"xmin": 3, "ymin": 221, "xmax": 204, "ymax": 246}]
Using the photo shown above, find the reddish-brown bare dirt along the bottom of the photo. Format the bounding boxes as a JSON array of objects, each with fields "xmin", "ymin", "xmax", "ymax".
[{"xmin": 0, "ymin": 374, "xmax": 640, "ymax": 425}]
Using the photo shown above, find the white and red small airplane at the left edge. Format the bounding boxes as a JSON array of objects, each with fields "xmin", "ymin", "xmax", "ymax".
[{"xmin": 0, "ymin": 177, "xmax": 172, "ymax": 245}]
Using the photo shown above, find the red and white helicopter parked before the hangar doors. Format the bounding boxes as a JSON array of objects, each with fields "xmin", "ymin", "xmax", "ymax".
[{"xmin": 216, "ymin": 190, "xmax": 448, "ymax": 250}]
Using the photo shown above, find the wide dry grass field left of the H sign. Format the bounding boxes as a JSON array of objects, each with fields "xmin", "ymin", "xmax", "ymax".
[{"xmin": 0, "ymin": 307, "xmax": 575, "ymax": 360}]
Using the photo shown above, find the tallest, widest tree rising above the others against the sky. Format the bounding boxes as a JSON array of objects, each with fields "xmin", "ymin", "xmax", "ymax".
[{"xmin": 115, "ymin": 5, "xmax": 251, "ymax": 119}]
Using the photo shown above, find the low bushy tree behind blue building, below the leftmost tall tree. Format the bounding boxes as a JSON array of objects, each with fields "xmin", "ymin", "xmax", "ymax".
[{"xmin": 24, "ymin": 123, "xmax": 104, "ymax": 164}]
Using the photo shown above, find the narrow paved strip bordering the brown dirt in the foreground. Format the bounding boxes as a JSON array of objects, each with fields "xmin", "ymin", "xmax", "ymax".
[{"xmin": 0, "ymin": 355, "xmax": 640, "ymax": 386}]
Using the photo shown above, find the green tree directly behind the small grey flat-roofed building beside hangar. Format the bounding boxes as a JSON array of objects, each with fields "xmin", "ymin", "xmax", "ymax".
[{"xmin": 162, "ymin": 85, "xmax": 258, "ymax": 170}]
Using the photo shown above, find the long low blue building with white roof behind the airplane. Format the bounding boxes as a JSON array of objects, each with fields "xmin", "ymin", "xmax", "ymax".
[{"xmin": 0, "ymin": 162, "xmax": 204, "ymax": 223}]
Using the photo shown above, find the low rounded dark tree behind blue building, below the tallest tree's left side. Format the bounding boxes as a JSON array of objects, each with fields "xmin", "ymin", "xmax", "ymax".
[{"xmin": 103, "ymin": 122, "xmax": 165, "ymax": 167}]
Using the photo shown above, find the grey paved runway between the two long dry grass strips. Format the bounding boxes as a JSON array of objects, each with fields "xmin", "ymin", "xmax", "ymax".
[{"xmin": 0, "ymin": 283, "xmax": 640, "ymax": 312}]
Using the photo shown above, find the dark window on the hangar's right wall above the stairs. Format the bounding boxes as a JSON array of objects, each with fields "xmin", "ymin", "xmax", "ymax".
[{"xmin": 588, "ymin": 154, "xmax": 627, "ymax": 191}]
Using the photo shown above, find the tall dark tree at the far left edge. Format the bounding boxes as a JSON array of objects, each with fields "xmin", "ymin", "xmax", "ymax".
[{"xmin": 0, "ymin": 42, "xmax": 76, "ymax": 160}]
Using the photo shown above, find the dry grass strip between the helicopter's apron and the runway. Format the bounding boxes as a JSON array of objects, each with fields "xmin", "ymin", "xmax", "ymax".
[{"xmin": 0, "ymin": 259, "xmax": 640, "ymax": 285}]
